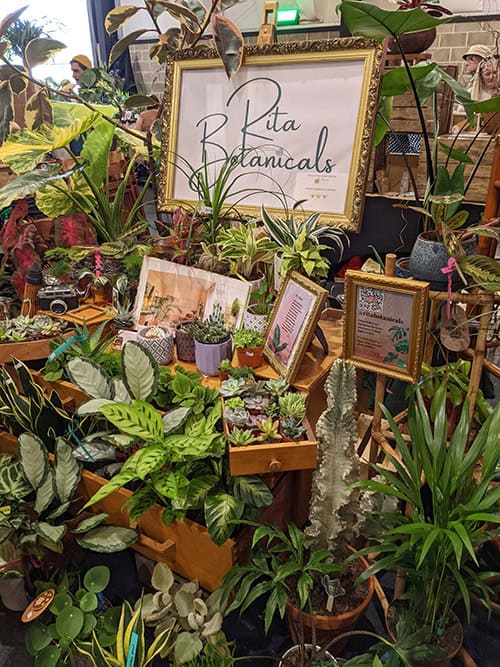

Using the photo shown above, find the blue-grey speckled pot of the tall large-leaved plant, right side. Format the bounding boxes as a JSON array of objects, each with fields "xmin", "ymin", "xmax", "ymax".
[{"xmin": 409, "ymin": 232, "xmax": 477, "ymax": 291}]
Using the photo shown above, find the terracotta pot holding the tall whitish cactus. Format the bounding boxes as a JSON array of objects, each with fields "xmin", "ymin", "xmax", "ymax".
[{"xmin": 286, "ymin": 546, "xmax": 375, "ymax": 651}]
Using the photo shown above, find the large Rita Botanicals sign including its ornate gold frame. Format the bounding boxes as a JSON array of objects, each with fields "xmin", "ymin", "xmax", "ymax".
[{"xmin": 159, "ymin": 38, "xmax": 382, "ymax": 230}]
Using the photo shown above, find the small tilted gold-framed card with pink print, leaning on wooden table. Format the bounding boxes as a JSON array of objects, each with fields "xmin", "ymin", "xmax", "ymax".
[{"xmin": 264, "ymin": 271, "xmax": 328, "ymax": 383}]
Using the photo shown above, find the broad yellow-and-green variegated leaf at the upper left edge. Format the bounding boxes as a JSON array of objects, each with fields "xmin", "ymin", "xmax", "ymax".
[{"xmin": 0, "ymin": 116, "xmax": 99, "ymax": 174}]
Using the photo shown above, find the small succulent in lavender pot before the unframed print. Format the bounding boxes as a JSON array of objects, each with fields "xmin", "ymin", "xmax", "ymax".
[{"xmin": 186, "ymin": 304, "xmax": 232, "ymax": 377}]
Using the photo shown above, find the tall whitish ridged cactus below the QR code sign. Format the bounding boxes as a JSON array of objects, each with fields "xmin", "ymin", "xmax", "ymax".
[{"xmin": 305, "ymin": 359, "xmax": 362, "ymax": 553}]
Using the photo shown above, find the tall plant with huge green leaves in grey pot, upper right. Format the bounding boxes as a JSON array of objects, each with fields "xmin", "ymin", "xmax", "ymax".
[{"xmin": 339, "ymin": 0, "xmax": 500, "ymax": 291}]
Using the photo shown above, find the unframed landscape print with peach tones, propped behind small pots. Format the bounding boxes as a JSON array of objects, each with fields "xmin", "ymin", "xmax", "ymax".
[{"xmin": 134, "ymin": 257, "xmax": 251, "ymax": 328}]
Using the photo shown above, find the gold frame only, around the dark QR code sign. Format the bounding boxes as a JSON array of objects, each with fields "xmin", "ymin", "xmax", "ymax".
[{"xmin": 343, "ymin": 271, "xmax": 429, "ymax": 383}]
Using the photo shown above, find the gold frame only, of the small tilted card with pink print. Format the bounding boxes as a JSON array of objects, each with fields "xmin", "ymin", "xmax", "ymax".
[{"xmin": 263, "ymin": 271, "xmax": 328, "ymax": 384}]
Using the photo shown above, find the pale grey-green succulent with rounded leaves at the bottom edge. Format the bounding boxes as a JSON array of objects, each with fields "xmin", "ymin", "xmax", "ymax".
[{"xmin": 142, "ymin": 563, "xmax": 225, "ymax": 665}]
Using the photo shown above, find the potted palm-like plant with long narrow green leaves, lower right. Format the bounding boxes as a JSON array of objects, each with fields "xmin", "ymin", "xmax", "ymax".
[{"xmin": 357, "ymin": 387, "xmax": 500, "ymax": 667}]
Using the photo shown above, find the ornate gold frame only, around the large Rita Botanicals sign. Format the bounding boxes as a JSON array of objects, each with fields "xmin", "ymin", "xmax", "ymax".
[{"xmin": 159, "ymin": 37, "xmax": 383, "ymax": 232}]
